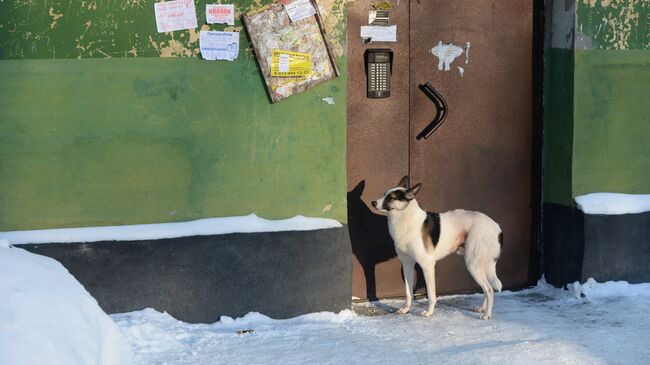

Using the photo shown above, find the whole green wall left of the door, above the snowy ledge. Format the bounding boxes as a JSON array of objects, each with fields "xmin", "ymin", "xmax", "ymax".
[{"xmin": 0, "ymin": 0, "xmax": 347, "ymax": 231}]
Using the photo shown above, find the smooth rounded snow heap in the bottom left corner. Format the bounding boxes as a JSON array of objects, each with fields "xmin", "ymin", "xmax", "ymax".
[{"xmin": 0, "ymin": 240, "xmax": 133, "ymax": 365}]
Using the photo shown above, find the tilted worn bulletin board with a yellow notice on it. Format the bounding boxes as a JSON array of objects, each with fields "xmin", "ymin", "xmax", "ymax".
[{"xmin": 242, "ymin": 1, "xmax": 339, "ymax": 103}]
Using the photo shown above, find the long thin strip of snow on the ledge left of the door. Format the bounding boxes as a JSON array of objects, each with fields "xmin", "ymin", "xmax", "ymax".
[{"xmin": 0, "ymin": 214, "xmax": 342, "ymax": 245}]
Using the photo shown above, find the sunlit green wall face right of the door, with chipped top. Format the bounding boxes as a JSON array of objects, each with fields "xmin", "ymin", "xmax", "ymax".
[{"xmin": 573, "ymin": 0, "xmax": 650, "ymax": 197}]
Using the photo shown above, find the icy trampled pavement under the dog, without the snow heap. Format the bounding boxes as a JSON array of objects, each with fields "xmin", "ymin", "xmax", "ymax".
[{"xmin": 112, "ymin": 282, "xmax": 650, "ymax": 364}]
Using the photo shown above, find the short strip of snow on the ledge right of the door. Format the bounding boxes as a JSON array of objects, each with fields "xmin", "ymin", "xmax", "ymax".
[{"xmin": 575, "ymin": 193, "xmax": 650, "ymax": 215}]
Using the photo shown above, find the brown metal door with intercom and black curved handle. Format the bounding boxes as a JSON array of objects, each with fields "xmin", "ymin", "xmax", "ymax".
[{"xmin": 348, "ymin": 0, "xmax": 533, "ymax": 299}]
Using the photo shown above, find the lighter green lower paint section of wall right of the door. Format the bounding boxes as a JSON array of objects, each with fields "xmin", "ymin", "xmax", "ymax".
[{"xmin": 573, "ymin": 50, "xmax": 650, "ymax": 196}]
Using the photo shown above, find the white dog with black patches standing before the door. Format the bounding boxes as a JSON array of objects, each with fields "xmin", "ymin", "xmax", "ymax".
[{"xmin": 372, "ymin": 176, "xmax": 503, "ymax": 319}]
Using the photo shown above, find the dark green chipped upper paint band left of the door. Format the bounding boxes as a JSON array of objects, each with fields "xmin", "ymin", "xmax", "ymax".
[{"xmin": 0, "ymin": 0, "xmax": 345, "ymax": 59}]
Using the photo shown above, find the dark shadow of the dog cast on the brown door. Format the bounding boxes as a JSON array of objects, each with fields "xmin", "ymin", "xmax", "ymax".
[{"xmin": 348, "ymin": 180, "xmax": 424, "ymax": 300}]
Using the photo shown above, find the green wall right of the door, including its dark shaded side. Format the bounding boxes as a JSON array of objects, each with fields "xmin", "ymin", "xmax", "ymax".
[{"xmin": 543, "ymin": 0, "xmax": 650, "ymax": 206}]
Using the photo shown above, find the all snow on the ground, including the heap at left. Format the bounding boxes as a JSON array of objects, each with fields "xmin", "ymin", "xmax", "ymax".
[{"xmin": 0, "ymin": 240, "xmax": 650, "ymax": 365}]
